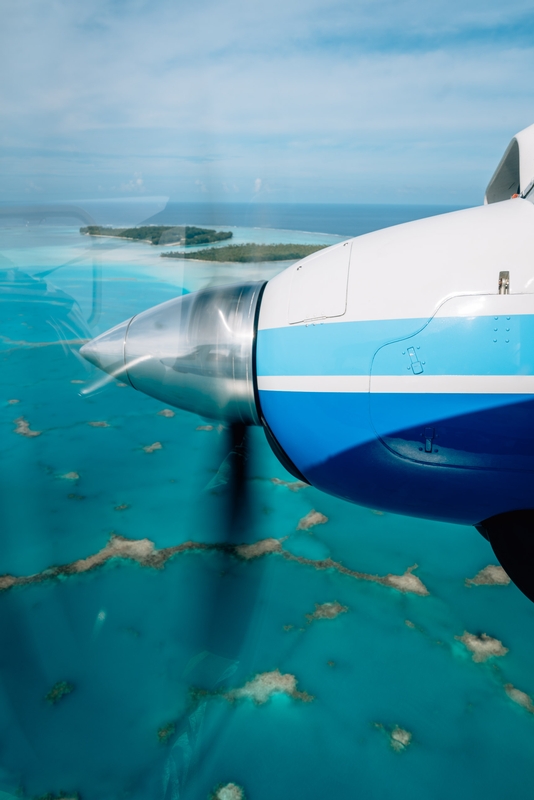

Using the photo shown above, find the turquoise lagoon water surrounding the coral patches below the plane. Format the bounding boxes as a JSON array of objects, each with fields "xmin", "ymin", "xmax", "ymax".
[{"xmin": 0, "ymin": 206, "xmax": 534, "ymax": 800}]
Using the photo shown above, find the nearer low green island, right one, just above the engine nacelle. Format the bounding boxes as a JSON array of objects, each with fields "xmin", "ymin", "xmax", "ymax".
[{"xmin": 161, "ymin": 242, "xmax": 328, "ymax": 264}]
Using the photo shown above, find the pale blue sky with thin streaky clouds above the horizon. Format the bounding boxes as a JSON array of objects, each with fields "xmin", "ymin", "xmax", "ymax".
[{"xmin": 0, "ymin": 0, "xmax": 534, "ymax": 205}]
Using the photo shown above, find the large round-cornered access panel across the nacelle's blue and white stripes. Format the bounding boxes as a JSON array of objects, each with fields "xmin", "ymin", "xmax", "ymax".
[{"xmin": 370, "ymin": 294, "xmax": 534, "ymax": 470}]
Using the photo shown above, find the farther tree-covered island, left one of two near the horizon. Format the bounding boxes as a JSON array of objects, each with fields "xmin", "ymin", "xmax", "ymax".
[{"xmin": 80, "ymin": 225, "xmax": 233, "ymax": 247}]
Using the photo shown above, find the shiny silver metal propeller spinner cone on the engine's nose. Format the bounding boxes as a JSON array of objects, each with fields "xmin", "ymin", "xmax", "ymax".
[{"xmin": 80, "ymin": 281, "xmax": 265, "ymax": 425}]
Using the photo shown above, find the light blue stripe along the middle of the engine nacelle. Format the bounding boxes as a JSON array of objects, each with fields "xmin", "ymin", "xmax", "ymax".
[{"xmin": 257, "ymin": 315, "xmax": 534, "ymax": 376}]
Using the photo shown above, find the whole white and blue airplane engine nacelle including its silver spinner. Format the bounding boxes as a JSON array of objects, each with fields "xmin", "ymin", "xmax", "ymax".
[{"xmin": 81, "ymin": 126, "xmax": 534, "ymax": 599}]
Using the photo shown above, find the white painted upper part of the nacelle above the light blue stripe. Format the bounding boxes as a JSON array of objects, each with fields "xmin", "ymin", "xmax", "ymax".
[{"xmin": 259, "ymin": 198, "xmax": 534, "ymax": 330}]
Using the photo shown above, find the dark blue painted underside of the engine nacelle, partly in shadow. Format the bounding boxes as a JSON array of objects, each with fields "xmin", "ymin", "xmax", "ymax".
[{"xmin": 260, "ymin": 391, "xmax": 534, "ymax": 524}]
